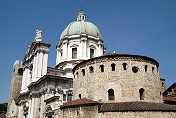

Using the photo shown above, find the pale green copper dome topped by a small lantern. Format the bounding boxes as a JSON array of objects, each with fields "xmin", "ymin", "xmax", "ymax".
[{"xmin": 60, "ymin": 10, "xmax": 101, "ymax": 39}]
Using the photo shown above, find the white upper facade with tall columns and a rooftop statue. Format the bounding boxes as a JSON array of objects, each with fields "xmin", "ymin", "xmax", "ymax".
[{"xmin": 21, "ymin": 30, "xmax": 51, "ymax": 93}]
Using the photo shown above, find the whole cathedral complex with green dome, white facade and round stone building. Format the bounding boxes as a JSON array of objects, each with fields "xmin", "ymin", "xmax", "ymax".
[{"xmin": 7, "ymin": 10, "xmax": 176, "ymax": 118}]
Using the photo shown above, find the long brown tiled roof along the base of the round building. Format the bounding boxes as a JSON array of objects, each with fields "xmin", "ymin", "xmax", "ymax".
[{"xmin": 100, "ymin": 102, "xmax": 176, "ymax": 112}]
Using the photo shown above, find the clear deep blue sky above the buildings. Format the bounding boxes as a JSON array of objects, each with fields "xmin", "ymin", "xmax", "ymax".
[{"xmin": 0, "ymin": 0, "xmax": 176, "ymax": 103}]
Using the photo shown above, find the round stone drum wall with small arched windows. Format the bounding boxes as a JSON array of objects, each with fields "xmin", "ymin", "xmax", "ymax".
[{"xmin": 73, "ymin": 54, "xmax": 162, "ymax": 102}]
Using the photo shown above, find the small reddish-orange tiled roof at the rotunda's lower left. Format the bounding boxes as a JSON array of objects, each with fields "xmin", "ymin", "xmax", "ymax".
[{"xmin": 62, "ymin": 98, "xmax": 99, "ymax": 108}]
